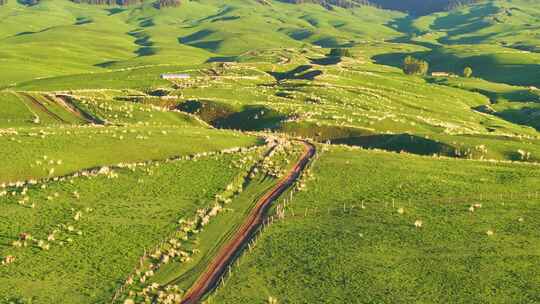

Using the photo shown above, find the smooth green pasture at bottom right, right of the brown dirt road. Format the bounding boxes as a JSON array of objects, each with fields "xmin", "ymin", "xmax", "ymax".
[{"xmin": 210, "ymin": 148, "xmax": 540, "ymax": 303}]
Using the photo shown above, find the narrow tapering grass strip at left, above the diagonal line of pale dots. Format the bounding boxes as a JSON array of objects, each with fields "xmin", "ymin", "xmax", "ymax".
[{"xmin": 0, "ymin": 126, "xmax": 257, "ymax": 182}]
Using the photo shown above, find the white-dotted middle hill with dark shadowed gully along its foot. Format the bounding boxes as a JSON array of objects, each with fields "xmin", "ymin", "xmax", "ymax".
[{"xmin": 169, "ymin": 55, "xmax": 540, "ymax": 163}]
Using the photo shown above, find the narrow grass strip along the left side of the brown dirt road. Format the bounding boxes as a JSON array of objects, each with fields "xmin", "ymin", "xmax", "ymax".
[{"xmin": 114, "ymin": 143, "xmax": 302, "ymax": 301}]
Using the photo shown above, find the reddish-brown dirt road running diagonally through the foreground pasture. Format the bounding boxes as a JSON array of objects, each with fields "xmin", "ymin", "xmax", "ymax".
[{"xmin": 182, "ymin": 142, "xmax": 315, "ymax": 304}]
